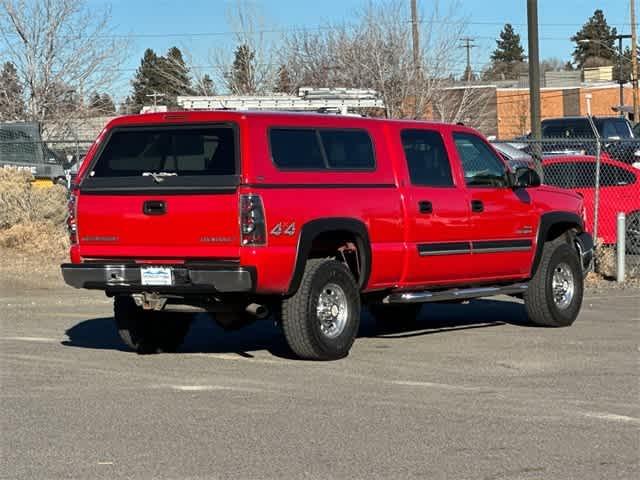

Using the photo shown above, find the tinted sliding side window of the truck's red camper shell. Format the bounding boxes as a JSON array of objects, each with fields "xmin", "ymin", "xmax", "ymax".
[{"xmin": 269, "ymin": 128, "xmax": 375, "ymax": 170}]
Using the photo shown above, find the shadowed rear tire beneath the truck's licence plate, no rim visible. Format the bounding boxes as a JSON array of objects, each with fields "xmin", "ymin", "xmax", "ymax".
[{"xmin": 113, "ymin": 296, "xmax": 192, "ymax": 354}]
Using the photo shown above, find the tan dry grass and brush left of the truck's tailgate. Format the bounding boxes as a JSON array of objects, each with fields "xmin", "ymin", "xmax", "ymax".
[{"xmin": 0, "ymin": 169, "xmax": 68, "ymax": 260}]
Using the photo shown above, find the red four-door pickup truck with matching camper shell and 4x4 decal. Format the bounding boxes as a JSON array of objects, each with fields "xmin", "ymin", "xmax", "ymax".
[{"xmin": 62, "ymin": 111, "xmax": 593, "ymax": 360}]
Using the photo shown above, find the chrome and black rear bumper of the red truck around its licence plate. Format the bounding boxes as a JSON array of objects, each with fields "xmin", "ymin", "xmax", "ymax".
[{"xmin": 60, "ymin": 263, "xmax": 255, "ymax": 293}]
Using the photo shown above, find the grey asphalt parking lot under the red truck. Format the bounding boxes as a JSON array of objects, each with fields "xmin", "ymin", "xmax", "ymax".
[{"xmin": 0, "ymin": 282, "xmax": 640, "ymax": 480}]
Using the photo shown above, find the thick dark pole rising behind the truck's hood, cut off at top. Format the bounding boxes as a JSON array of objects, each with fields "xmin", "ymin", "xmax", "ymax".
[{"xmin": 527, "ymin": 0, "xmax": 542, "ymax": 154}]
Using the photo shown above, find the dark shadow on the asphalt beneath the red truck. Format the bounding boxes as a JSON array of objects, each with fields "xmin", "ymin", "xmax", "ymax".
[{"xmin": 62, "ymin": 299, "xmax": 532, "ymax": 358}]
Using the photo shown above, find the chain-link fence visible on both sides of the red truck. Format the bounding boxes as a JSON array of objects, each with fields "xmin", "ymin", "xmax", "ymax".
[{"xmin": 0, "ymin": 133, "xmax": 640, "ymax": 277}]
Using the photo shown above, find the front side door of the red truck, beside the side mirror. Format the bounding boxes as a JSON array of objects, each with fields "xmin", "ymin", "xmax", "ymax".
[{"xmin": 453, "ymin": 131, "xmax": 539, "ymax": 280}]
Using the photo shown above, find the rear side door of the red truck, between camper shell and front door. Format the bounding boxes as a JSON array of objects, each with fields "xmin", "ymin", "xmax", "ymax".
[{"xmin": 399, "ymin": 129, "xmax": 471, "ymax": 285}]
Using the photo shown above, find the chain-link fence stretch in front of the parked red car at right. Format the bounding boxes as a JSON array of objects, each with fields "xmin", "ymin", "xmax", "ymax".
[{"xmin": 494, "ymin": 138, "xmax": 640, "ymax": 277}]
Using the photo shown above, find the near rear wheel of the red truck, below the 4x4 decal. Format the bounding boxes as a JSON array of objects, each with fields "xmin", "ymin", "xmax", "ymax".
[{"xmin": 282, "ymin": 259, "xmax": 360, "ymax": 360}]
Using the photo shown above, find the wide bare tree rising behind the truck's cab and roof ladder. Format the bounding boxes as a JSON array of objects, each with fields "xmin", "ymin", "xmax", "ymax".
[{"xmin": 280, "ymin": 0, "xmax": 492, "ymax": 120}]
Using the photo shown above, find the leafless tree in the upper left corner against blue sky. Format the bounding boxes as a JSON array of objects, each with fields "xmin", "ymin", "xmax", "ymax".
[{"xmin": 0, "ymin": 0, "xmax": 126, "ymax": 136}]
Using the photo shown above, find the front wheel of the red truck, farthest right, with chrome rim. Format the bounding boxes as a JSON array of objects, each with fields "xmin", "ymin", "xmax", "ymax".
[{"xmin": 524, "ymin": 236, "xmax": 584, "ymax": 327}]
